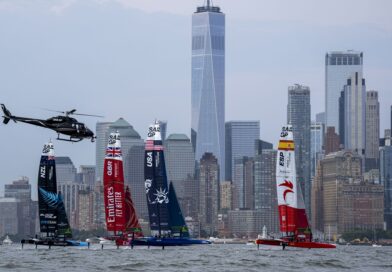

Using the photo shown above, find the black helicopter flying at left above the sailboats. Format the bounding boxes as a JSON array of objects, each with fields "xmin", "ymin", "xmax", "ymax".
[{"xmin": 1, "ymin": 104, "xmax": 103, "ymax": 143}]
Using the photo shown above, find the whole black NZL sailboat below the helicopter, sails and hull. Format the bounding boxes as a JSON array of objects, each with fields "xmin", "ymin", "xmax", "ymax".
[{"xmin": 21, "ymin": 142, "xmax": 87, "ymax": 247}]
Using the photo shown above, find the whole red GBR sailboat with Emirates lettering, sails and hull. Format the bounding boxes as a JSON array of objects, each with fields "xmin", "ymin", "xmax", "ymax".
[{"xmin": 100, "ymin": 132, "xmax": 143, "ymax": 246}]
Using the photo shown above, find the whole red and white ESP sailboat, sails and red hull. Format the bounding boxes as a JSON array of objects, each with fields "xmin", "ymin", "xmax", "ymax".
[{"xmin": 255, "ymin": 125, "xmax": 336, "ymax": 249}]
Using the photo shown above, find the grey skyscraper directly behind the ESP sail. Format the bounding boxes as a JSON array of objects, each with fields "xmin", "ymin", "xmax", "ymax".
[{"xmin": 287, "ymin": 84, "xmax": 311, "ymax": 215}]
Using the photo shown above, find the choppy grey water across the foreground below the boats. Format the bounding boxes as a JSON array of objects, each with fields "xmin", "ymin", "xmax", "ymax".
[{"xmin": 0, "ymin": 244, "xmax": 392, "ymax": 272}]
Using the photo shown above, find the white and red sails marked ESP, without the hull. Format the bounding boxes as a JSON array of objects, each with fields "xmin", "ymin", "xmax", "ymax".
[{"xmin": 276, "ymin": 126, "xmax": 311, "ymax": 236}]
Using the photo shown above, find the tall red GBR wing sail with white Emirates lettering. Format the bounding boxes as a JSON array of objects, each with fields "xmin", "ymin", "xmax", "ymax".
[{"xmin": 103, "ymin": 132, "xmax": 125, "ymax": 234}]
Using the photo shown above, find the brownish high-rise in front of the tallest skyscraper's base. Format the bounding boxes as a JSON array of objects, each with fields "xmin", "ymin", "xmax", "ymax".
[{"xmin": 199, "ymin": 153, "xmax": 220, "ymax": 236}]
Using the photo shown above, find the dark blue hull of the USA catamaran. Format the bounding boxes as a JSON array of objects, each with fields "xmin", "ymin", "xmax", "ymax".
[{"xmin": 131, "ymin": 237, "xmax": 211, "ymax": 247}]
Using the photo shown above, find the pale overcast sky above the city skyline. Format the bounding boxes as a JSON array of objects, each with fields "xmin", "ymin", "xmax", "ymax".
[{"xmin": 0, "ymin": 0, "xmax": 392, "ymax": 195}]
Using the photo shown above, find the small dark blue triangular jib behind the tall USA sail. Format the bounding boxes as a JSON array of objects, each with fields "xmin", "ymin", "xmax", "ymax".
[{"xmin": 169, "ymin": 182, "xmax": 189, "ymax": 237}]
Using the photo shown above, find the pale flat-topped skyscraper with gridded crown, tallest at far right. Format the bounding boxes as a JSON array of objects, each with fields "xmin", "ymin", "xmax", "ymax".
[{"xmin": 325, "ymin": 50, "xmax": 363, "ymax": 131}]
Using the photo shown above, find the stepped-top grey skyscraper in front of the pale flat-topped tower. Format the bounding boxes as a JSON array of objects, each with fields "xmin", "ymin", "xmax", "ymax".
[{"xmin": 342, "ymin": 72, "xmax": 366, "ymax": 156}]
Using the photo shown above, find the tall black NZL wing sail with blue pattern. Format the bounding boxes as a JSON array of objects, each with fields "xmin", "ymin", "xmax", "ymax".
[{"xmin": 38, "ymin": 143, "xmax": 58, "ymax": 237}]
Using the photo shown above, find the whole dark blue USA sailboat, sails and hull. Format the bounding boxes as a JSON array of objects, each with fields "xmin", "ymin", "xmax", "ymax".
[{"xmin": 133, "ymin": 121, "xmax": 210, "ymax": 248}]
